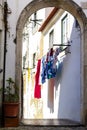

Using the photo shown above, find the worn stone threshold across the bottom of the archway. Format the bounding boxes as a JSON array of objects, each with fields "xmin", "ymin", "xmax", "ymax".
[{"xmin": 21, "ymin": 119, "xmax": 83, "ymax": 127}]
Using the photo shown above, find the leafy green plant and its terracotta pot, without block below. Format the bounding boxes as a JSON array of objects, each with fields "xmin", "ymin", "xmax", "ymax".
[{"xmin": 3, "ymin": 78, "xmax": 19, "ymax": 116}]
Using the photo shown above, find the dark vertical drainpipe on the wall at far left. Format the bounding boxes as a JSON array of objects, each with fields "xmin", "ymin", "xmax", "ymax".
[{"xmin": 2, "ymin": 2, "xmax": 8, "ymax": 125}]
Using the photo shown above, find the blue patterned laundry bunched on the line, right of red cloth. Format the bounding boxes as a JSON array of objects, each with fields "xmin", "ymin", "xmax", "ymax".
[{"xmin": 41, "ymin": 48, "xmax": 61, "ymax": 84}]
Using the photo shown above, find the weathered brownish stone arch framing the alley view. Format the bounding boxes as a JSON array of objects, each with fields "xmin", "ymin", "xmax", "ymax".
[{"xmin": 15, "ymin": 0, "xmax": 87, "ymax": 123}]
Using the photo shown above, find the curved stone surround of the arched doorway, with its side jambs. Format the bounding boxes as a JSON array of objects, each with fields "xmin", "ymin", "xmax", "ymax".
[{"xmin": 16, "ymin": 0, "xmax": 86, "ymax": 122}]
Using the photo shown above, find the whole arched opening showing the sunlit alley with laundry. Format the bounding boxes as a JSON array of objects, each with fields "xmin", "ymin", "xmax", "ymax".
[{"xmin": 22, "ymin": 7, "xmax": 81, "ymax": 122}]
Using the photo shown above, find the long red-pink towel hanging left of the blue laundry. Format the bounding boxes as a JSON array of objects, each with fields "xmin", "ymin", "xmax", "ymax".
[{"xmin": 34, "ymin": 59, "xmax": 41, "ymax": 98}]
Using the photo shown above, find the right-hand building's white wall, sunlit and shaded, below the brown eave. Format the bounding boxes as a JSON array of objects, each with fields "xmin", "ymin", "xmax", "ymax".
[{"xmin": 43, "ymin": 12, "xmax": 81, "ymax": 121}]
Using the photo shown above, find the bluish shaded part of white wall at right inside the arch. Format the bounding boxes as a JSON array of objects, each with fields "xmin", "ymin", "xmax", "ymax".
[{"xmin": 58, "ymin": 16, "xmax": 81, "ymax": 121}]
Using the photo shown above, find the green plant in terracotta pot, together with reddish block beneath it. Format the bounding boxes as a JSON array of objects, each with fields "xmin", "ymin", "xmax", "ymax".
[{"xmin": 0, "ymin": 77, "xmax": 19, "ymax": 126}]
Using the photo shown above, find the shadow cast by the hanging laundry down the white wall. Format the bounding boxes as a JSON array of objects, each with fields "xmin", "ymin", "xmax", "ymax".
[{"xmin": 48, "ymin": 52, "xmax": 63, "ymax": 113}]
